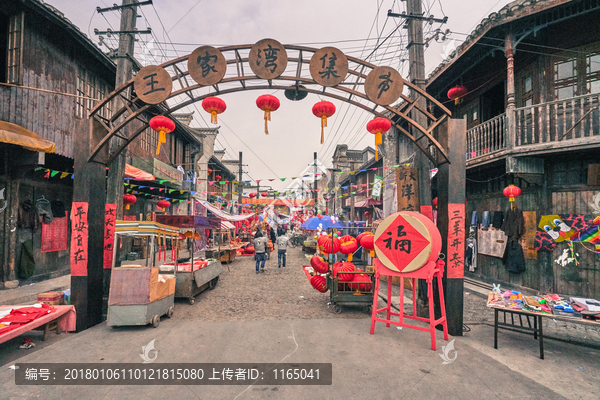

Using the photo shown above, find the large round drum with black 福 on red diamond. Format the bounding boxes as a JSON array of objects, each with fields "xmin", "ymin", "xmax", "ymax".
[{"xmin": 375, "ymin": 211, "xmax": 442, "ymax": 272}]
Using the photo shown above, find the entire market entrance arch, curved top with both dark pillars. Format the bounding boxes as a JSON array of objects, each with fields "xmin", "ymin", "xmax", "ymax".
[{"xmin": 71, "ymin": 39, "xmax": 466, "ymax": 335}]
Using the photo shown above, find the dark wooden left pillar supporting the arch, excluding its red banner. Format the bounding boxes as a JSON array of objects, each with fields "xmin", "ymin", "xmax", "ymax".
[{"xmin": 71, "ymin": 120, "xmax": 107, "ymax": 331}]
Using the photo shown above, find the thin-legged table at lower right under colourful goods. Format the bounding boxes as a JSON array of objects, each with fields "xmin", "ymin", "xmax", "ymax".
[{"xmin": 487, "ymin": 292, "xmax": 600, "ymax": 360}]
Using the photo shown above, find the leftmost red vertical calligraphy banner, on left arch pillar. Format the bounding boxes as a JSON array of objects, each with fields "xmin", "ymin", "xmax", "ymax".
[{"xmin": 71, "ymin": 202, "xmax": 88, "ymax": 276}]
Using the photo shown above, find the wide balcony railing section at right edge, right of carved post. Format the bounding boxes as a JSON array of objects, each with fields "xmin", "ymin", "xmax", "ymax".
[{"xmin": 515, "ymin": 94, "xmax": 600, "ymax": 147}]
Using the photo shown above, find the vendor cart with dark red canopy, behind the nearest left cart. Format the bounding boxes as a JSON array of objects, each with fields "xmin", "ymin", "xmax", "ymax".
[{"xmin": 157, "ymin": 215, "xmax": 223, "ymax": 304}]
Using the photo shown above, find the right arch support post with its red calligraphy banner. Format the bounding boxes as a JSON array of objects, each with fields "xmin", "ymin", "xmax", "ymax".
[{"xmin": 434, "ymin": 119, "xmax": 467, "ymax": 336}]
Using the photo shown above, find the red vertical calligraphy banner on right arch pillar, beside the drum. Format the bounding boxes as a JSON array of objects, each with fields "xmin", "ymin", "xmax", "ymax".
[{"xmin": 446, "ymin": 203, "xmax": 465, "ymax": 279}]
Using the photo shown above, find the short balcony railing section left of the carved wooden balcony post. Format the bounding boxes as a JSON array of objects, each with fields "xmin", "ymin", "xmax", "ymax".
[{"xmin": 467, "ymin": 114, "xmax": 507, "ymax": 161}]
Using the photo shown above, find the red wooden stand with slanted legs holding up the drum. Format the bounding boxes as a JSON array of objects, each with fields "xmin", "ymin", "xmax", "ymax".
[{"xmin": 371, "ymin": 258, "xmax": 448, "ymax": 351}]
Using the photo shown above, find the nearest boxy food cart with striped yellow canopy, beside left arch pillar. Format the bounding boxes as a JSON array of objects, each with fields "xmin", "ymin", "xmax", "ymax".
[{"xmin": 106, "ymin": 221, "xmax": 179, "ymax": 328}]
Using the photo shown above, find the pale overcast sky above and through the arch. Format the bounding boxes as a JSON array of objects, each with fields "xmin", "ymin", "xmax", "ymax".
[{"xmin": 46, "ymin": 0, "xmax": 510, "ymax": 189}]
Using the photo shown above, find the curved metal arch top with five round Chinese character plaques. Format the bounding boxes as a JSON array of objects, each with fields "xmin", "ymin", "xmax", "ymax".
[{"xmin": 88, "ymin": 39, "xmax": 450, "ymax": 165}]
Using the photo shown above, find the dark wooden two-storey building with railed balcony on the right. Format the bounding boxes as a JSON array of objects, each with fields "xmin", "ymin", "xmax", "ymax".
[{"xmin": 427, "ymin": 0, "xmax": 600, "ymax": 298}]
